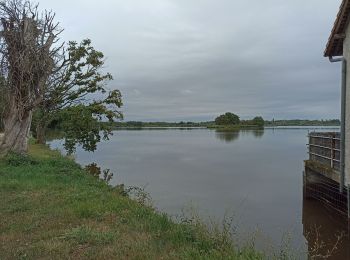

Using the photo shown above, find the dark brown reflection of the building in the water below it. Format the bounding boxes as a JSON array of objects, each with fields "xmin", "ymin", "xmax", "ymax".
[{"xmin": 303, "ymin": 195, "xmax": 350, "ymax": 260}]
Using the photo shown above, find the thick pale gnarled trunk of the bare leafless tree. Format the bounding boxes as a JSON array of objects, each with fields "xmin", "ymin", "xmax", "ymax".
[{"xmin": 0, "ymin": 109, "xmax": 32, "ymax": 157}]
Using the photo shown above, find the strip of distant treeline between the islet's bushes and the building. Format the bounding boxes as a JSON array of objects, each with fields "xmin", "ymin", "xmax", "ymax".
[{"xmin": 265, "ymin": 119, "xmax": 340, "ymax": 127}]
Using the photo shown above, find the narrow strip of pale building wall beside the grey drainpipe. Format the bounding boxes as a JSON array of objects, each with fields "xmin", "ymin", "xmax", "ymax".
[{"xmin": 344, "ymin": 26, "xmax": 350, "ymax": 185}]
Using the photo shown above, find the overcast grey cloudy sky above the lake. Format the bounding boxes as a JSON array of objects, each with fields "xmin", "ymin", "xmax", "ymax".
[{"xmin": 40, "ymin": 0, "xmax": 341, "ymax": 121}]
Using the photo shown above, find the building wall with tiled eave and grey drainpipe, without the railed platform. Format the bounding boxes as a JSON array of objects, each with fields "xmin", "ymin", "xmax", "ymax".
[{"xmin": 324, "ymin": 0, "xmax": 350, "ymax": 186}]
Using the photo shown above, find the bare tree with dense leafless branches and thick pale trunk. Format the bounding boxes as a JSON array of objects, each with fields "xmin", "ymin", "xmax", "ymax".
[{"xmin": 0, "ymin": 0, "xmax": 62, "ymax": 156}]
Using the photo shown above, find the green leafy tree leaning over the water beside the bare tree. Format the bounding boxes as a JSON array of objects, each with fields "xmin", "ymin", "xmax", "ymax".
[{"xmin": 32, "ymin": 39, "xmax": 122, "ymax": 152}]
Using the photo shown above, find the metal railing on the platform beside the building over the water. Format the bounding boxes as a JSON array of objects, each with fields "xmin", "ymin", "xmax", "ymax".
[{"xmin": 308, "ymin": 132, "xmax": 340, "ymax": 171}]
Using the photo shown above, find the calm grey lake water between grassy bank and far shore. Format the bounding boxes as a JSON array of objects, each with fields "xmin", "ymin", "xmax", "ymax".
[{"xmin": 50, "ymin": 128, "xmax": 350, "ymax": 260}]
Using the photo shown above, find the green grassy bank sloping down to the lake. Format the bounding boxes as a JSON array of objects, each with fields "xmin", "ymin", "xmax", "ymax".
[{"xmin": 0, "ymin": 145, "xmax": 262, "ymax": 259}]
